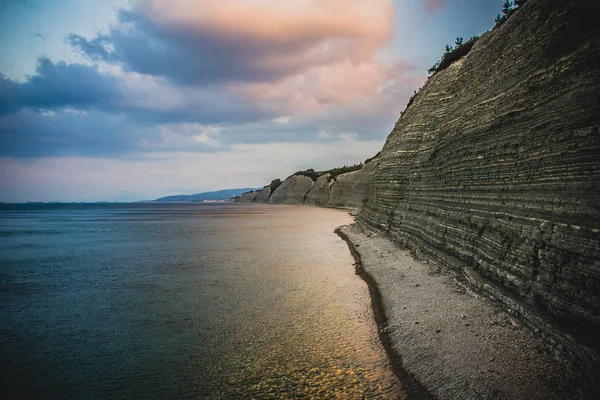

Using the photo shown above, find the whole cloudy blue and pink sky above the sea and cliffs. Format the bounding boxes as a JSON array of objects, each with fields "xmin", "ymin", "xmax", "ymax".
[{"xmin": 0, "ymin": 0, "xmax": 504, "ymax": 202}]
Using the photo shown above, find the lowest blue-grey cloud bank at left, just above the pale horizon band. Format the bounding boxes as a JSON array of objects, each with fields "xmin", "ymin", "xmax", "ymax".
[{"xmin": 0, "ymin": 109, "xmax": 234, "ymax": 158}]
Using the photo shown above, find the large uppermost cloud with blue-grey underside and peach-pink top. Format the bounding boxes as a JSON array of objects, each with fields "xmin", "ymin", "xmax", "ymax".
[{"xmin": 69, "ymin": 0, "xmax": 393, "ymax": 84}]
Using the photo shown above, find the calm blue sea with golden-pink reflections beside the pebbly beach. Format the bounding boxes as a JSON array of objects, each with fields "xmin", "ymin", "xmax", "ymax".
[{"xmin": 0, "ymin": 204, "xmax": 403, "ymax": 399}]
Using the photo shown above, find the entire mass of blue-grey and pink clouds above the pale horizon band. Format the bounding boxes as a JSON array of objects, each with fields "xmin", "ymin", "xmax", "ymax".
[{"xmin": 0, "ymin": 0, "xmax": 424, "ymax": 158}]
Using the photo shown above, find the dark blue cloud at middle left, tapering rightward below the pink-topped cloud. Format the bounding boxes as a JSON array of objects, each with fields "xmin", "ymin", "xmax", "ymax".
[{"xmin": 0, "ymin": 58, "xmax": 265, "ymax": 124}]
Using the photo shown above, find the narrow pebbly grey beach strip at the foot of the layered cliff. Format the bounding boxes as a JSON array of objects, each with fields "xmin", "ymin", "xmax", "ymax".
[{"xmin": 338, "ymin": 225, "xmax": 576, "ymax": 399}]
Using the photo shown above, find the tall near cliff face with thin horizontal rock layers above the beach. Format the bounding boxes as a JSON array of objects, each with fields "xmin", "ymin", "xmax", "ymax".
[{"xmin": 358, "ymin": 0, "xmax": 600, "ymax": 378}]
